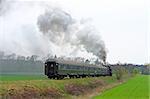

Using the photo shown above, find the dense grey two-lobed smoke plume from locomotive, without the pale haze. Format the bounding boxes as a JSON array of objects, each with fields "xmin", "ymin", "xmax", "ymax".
[{"xmin": 37, "ymin": 9, "xmax": 106, "ymax": 62}]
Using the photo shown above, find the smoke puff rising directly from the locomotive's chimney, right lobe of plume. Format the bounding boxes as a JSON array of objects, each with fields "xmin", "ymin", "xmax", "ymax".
[{"xmin": 77, "ymin": 25, "xmax": 107, "ymax": 62}]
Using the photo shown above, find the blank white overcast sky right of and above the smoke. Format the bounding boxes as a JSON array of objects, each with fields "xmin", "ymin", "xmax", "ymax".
[{"xmin": 0, "ymin": 0, "xmax": 150, "ymax": 64}]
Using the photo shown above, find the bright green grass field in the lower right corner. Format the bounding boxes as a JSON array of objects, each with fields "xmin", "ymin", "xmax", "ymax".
[{"xmin": 94, "ymin": 75, "xmax": 150, "ymax": 99}]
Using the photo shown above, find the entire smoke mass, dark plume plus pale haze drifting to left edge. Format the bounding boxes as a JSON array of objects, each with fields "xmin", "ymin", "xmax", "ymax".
[{"xmin": 0, "ymin": 0, "xmax": 106, "ymax": 60}]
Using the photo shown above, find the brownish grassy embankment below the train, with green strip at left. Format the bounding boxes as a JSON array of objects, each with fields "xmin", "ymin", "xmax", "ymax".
[{"xmin": 0, "ymin": 75, "xmax": 117, "ymax": 99}]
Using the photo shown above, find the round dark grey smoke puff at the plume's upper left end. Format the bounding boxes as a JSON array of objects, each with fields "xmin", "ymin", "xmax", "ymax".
[{"xmin": 37, "ymin": 9, "xmax": 73, "ymax": 44}]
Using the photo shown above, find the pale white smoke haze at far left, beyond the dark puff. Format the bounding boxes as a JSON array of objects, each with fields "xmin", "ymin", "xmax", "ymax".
[{"xmin": 0, "ymin": 0, "xmax": 49, "ymax": 56}]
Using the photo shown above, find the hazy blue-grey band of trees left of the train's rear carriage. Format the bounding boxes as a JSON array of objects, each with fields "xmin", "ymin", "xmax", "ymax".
[{"xmin": 0, "ymin": 51, "xmax": 44, "ymax": 74}]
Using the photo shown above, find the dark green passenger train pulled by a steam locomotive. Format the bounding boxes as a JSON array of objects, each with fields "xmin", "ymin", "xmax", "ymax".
[{"xmin": 45, "ymin": 59, "xmax": 112, "ymax": 79}]
